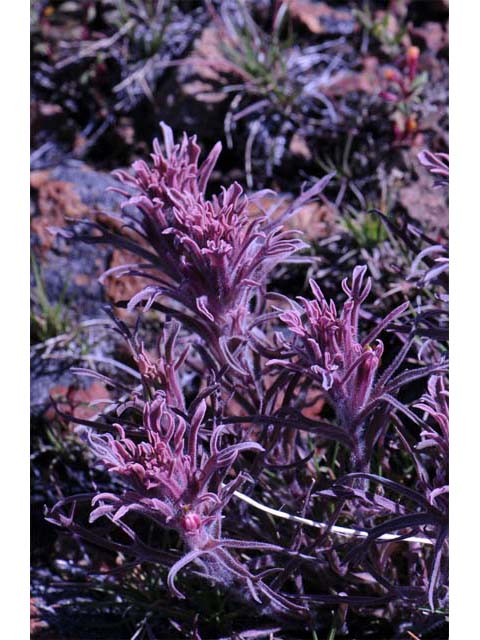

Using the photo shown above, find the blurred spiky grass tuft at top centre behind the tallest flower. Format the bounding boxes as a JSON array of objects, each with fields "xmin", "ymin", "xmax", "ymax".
[{"xmin": 187, "ymin": 0, "xmax": 344, "ymax": 188}]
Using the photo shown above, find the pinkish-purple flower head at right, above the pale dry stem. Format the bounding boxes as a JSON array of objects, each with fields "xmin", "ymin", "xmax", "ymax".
[{"xmin": 268, "ymin": 266, "xmax": 442, "ymax": 466}]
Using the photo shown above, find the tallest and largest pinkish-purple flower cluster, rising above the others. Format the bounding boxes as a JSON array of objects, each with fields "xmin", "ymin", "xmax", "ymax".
[{"xmin": 100, "ymin": 124, "xmax": 325, "ymax": 343}]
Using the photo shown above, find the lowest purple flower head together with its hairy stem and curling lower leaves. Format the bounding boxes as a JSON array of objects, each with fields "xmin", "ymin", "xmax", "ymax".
[{"xmin": 48, "ymin": 391, "xmax": 306, "ymax": 615}]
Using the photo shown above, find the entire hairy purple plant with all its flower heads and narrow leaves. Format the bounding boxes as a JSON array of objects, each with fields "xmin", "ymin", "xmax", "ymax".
[{"xmin": 48, "ymin": 125, "xmax": 448, "ymax": 618}]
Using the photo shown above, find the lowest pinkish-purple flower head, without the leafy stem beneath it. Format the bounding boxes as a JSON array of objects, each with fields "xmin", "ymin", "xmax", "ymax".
[{"xmin": 88, "ymin": 392, "xmax": 262, "ymax": 549}]
